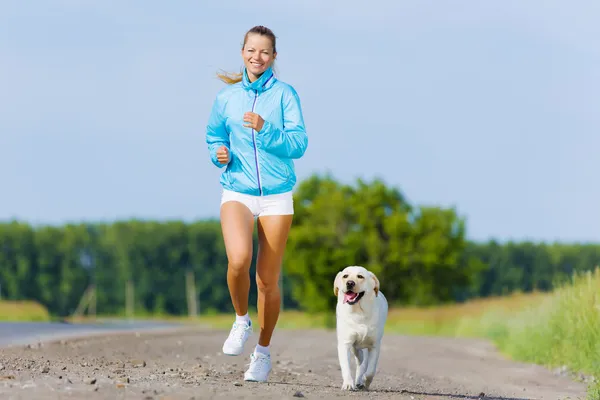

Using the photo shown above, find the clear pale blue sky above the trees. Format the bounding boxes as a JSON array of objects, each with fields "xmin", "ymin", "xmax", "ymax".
[{"xmin": 0, "ymin": 0, "xmax": 600, "ymax": 242}]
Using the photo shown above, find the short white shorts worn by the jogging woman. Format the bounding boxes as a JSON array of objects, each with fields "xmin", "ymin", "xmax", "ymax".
[{"xmin": 221, "ymin": 189, "xmax": 294, "ymax": 217}]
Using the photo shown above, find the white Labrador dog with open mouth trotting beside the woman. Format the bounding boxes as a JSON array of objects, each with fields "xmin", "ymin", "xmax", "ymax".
[{"xmin": 333, "ymin": 266, "xmax": 388, "ymax": 390}]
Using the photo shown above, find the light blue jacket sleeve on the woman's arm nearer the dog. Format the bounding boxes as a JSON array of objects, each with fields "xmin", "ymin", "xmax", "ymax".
[{"xmin": 258, "ymin": 89, "xmax": 308, "ymax": 158}]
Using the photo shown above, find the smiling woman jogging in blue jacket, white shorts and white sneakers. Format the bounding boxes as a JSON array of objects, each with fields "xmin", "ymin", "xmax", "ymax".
[{"xmin": 206, "ymin": 26, "xmax": 308, "ymax": 382}]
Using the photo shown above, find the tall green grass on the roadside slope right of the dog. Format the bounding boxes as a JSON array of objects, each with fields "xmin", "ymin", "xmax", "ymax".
[{"xmin": 388, "ymin": 268, "xmax": 600, "ymax": 400}]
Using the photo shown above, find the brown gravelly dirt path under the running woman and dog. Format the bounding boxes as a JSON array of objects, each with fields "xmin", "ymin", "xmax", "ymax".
[{"xmin": 0, "ymin": 328, "xmax": 585, "ymax": 400}]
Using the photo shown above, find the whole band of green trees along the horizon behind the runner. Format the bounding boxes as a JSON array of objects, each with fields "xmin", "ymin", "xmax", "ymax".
[{"xmin": 0, "ymin": 175, "xmax": 600, "ymax": 316}]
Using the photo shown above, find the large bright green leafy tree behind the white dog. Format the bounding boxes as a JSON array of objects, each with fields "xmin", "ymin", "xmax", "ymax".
[{"xmin": 286, "ymin": 176, "xmax": 479, "ymax": 312}]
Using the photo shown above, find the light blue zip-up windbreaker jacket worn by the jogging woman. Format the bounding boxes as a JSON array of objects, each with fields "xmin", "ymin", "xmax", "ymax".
[{"xmin": 206, "ymin": 68, "xmax": 308, "ymax": 196}]
